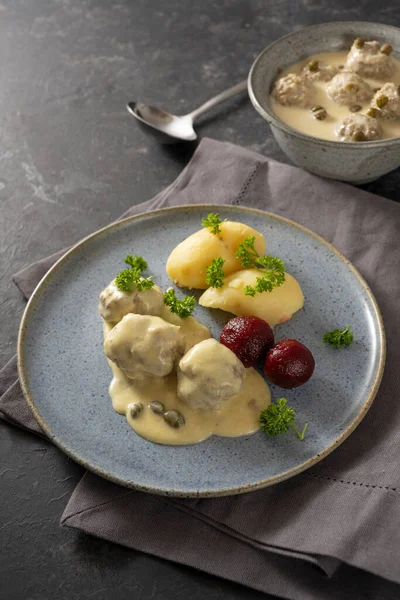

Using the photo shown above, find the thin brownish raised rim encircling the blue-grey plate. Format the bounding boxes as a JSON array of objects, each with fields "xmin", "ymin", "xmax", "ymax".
[{"xmin": 17, "ymin": 203, "xmax": 386, "ymax": 498}]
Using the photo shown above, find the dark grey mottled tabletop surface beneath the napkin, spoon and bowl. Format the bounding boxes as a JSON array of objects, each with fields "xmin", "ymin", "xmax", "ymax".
[{"xmin": 0, "ymin": 0, "xmax": 400, "ymax": 600}]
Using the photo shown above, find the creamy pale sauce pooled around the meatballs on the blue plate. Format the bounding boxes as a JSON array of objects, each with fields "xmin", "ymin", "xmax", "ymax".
[{"xmin": 103, "ymin": 318, "xmax": 271, "ymax": 445}]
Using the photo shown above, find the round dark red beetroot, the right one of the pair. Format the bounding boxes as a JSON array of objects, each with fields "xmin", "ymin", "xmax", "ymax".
[{"xmin": 264, "ymin": 340, "xmax": 315, "ymax": 389}]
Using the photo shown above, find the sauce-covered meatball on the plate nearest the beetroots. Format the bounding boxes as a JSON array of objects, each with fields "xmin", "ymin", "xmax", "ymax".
[{"xmin": 178, "ymin": 339, "xmax": 246, "ymax": 409}]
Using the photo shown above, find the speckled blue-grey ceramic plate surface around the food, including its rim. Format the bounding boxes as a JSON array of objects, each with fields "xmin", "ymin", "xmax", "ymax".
[{"xmin": 18, "ymin": 205, "xmax": 385, "ymax": 496}]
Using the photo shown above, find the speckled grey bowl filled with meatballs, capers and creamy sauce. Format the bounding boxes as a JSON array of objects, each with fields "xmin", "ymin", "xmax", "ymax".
[{"xmin": 248, "ymin": 22, "xmax": 400, "ymax": 184}]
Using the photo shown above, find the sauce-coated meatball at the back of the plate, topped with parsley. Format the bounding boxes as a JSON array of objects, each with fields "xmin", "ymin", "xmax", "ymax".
[{"xmin": 99, "ymin": 279, "xmax": 164, "ymax": 323}]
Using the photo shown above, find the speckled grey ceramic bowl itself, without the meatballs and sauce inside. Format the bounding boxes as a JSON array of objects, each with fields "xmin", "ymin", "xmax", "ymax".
[{"xmin": 248, "ymin": 21, "xmax": 400, "ymax": 184}]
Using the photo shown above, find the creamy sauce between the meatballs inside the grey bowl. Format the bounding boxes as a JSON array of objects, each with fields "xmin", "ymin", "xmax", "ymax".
[{"xmin": 269, "ymin": 50, "xmax": 400, "ymax": 141}]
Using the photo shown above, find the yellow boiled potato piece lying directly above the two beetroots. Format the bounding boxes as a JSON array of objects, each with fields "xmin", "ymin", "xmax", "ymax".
[{"xmin": 199, "ymin": 269, "xmax": 304, "ymax": 327}]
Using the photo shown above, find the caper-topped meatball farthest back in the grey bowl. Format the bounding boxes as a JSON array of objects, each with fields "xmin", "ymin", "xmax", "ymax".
[{"xmin": 346, "ymin": 38, "xmax": 395, "ymax": 79}]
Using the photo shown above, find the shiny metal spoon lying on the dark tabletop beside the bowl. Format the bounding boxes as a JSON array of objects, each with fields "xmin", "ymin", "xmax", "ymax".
[{"xmin": 126, "ymin": 79, "xmax": 247, "ymax": 144}]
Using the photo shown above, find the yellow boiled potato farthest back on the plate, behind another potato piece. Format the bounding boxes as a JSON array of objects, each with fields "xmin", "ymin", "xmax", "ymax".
[{"xmin": 167, "ymin": 221, "xmax": 266, "ymax": 290}]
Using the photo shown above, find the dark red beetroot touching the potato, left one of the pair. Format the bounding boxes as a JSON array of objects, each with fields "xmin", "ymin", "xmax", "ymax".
[{"xmin": 219, "ymin": 316, "xmax": 274, "ymax": 367}]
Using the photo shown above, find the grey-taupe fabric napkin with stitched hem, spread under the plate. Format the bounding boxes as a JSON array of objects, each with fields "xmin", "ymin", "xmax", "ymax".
[{"xmin": 0, "ymin": 139, "xmax": 400, "ymax": 599}]
